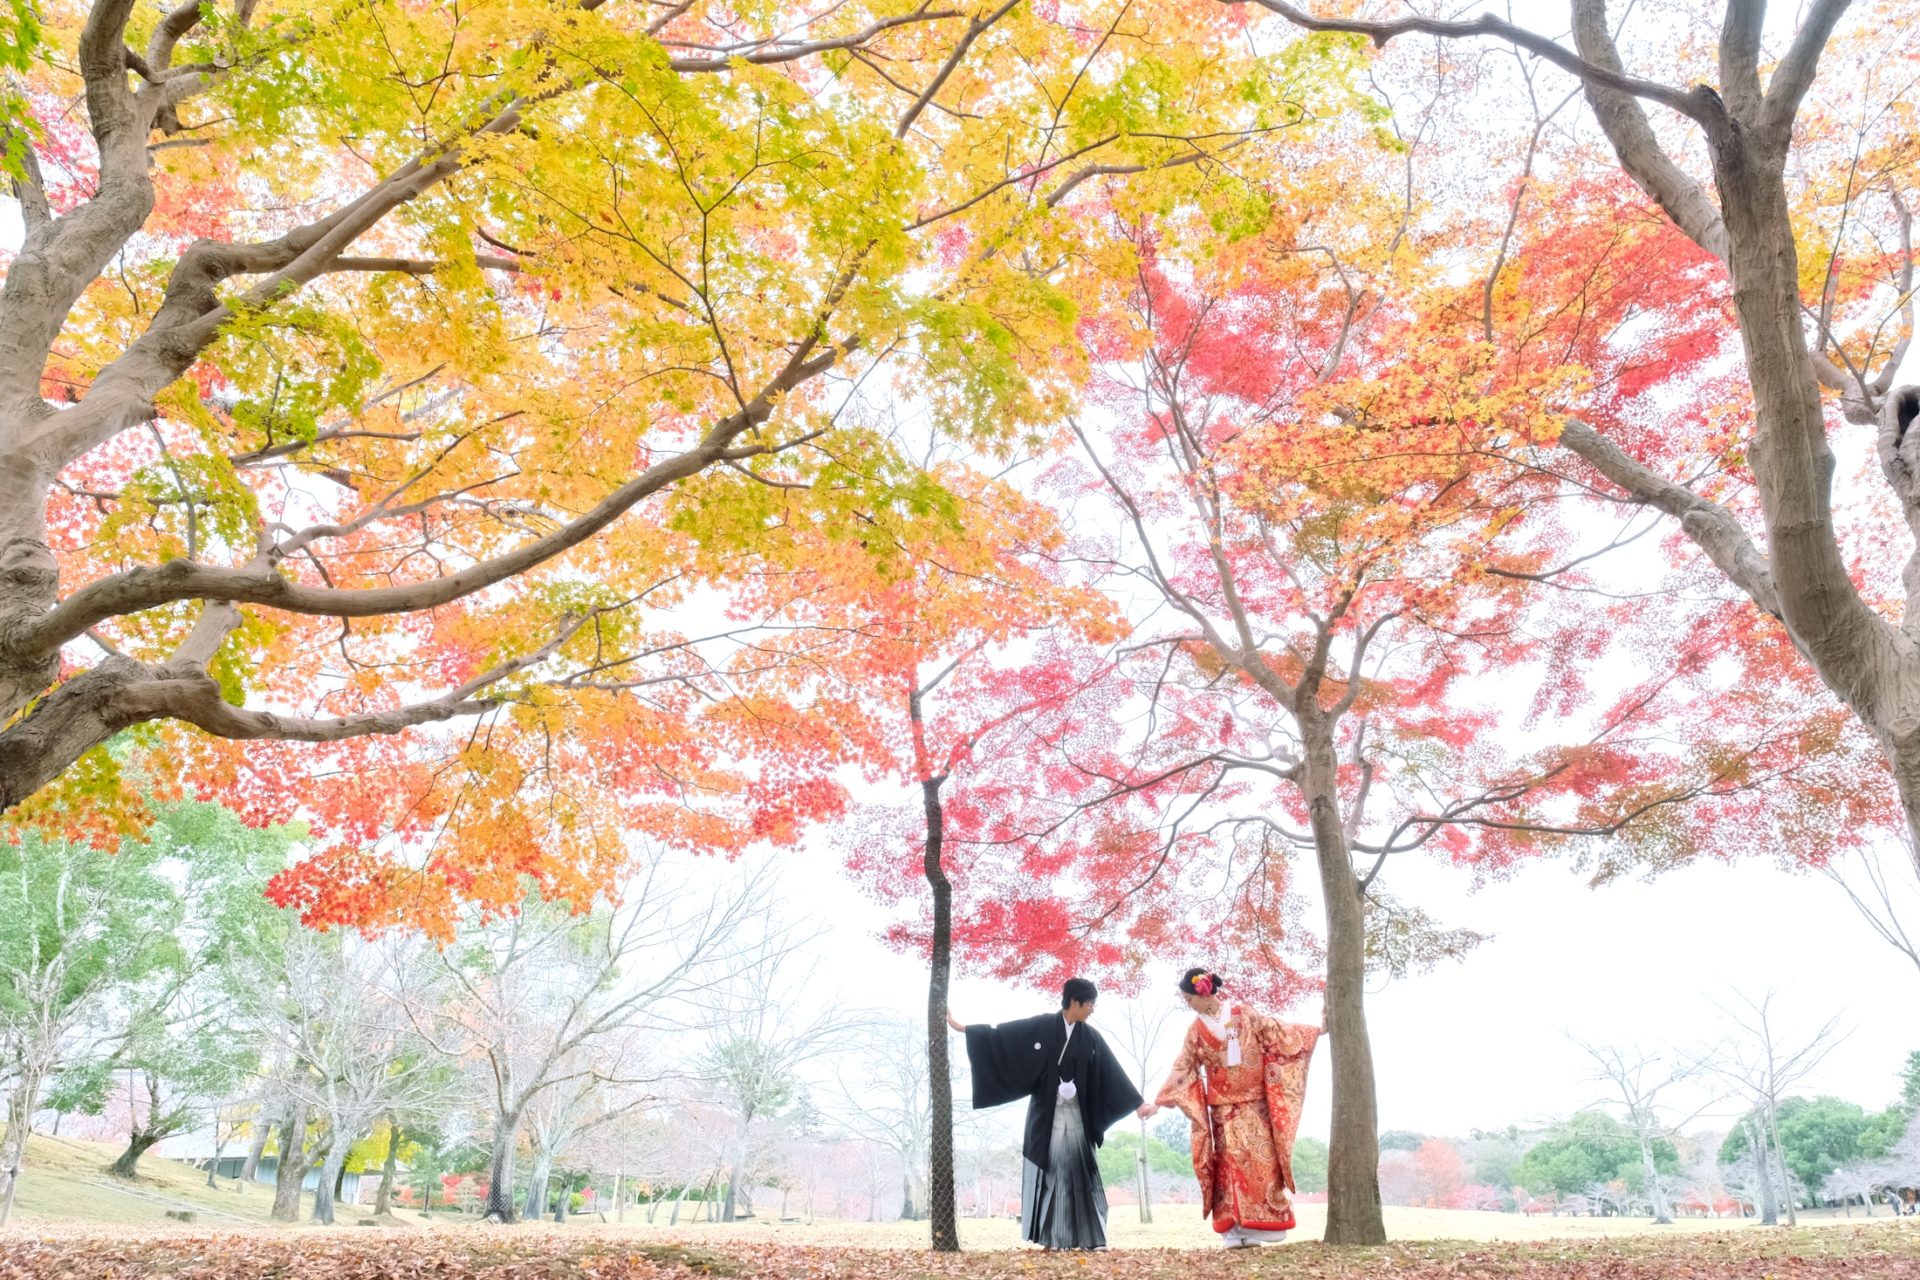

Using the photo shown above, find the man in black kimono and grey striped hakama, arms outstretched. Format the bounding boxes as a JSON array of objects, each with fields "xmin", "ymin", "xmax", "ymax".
[{"xmin": 947, "ymin": 979, "xmax": 1140, "ymax": 1249}]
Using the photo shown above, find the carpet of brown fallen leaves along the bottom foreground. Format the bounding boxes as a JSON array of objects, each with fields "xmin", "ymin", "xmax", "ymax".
[{"xmin": 0, "ymin": 1224, "xmax": 1920, "ymax": 1280}]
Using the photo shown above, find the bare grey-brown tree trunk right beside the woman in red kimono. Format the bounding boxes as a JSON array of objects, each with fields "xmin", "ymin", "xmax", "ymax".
[{"xmin": 1300, "ymin": 714, "xmax": 1386, "ymax": 1245}]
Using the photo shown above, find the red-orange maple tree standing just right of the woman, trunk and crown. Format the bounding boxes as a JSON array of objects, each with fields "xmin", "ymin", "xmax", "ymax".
[{"xmin": 1044, "ymin": 92, "xmax": 1849, "ymax": 1244}]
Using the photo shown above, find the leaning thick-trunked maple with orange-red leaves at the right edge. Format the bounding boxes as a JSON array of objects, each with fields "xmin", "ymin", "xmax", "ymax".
[{"xmin": 1228, "ymin": 0, "xmax": 1920, "ymax": 871}]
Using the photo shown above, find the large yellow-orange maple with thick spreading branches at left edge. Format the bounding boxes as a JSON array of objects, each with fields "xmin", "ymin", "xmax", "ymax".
[{"xmin": 0, "ymin": 0, "xmax": 1328, "ymax": 935}]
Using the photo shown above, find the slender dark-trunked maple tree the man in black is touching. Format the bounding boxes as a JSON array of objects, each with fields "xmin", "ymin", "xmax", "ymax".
[{"xmin": 760, "ymin": 461, "xmax": 1116, "ymax": 1251}]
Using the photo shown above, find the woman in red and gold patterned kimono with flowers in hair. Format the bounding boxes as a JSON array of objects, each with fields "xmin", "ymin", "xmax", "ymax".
[{"xmin": 1154, "ymin": 969, "xmax": 1321, "ymax": 1249}]
